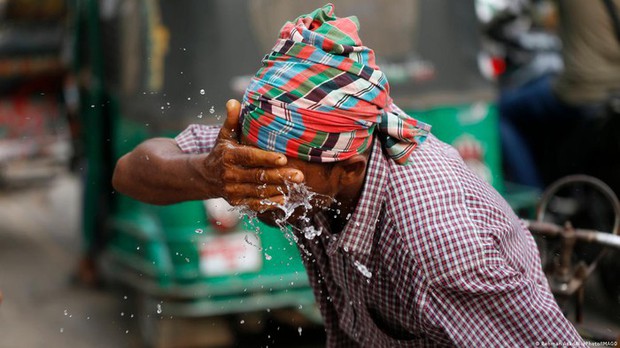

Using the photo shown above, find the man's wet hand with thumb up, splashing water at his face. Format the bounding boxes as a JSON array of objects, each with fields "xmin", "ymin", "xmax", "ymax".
[{"xmin": 203, "ymin": 100, "xmax": 304, "ymax": 212}]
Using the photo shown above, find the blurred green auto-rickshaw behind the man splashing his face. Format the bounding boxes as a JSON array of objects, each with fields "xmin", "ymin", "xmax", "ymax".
[{"xmin": 72, "ymin": 0, "xmax": 531, "ymax": 345}]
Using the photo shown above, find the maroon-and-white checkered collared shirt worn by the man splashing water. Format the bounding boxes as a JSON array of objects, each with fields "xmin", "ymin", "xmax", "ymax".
[{"xmin": 176, "ymin": 125, "xmax": 585, "ymax": 347}]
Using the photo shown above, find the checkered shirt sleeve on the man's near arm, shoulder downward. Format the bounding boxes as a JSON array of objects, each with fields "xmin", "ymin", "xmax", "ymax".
[{"xmin": 398, "ymin": 140, "xmax": 585, "ymax": 347}]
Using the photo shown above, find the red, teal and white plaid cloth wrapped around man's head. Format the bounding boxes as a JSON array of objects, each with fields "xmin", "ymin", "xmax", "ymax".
[{"xmin": 240, "ymin": 4, "xmax": 430, "ymax": 164}]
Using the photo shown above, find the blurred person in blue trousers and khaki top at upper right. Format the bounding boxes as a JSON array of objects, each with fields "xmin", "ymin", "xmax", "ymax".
[{"xmin": 498, "ymin": 0, "xmax": 620, "ymax": 188}]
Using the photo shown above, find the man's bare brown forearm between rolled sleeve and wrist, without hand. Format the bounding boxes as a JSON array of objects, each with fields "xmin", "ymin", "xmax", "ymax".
[{"xmin": 112, "ymin": 138, "xmax": 213, "ymax": 205}]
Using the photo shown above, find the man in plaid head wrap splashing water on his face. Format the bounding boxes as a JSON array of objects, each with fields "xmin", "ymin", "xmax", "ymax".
[{"xmin": 114, "ymin": 5, "xmax": 583, "ymax": 347}]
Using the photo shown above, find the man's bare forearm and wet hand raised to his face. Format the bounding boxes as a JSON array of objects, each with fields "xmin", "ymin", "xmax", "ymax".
[{"xmin": 112, "ymin": 100, "xmax": 304, "ymax": 207}]
